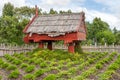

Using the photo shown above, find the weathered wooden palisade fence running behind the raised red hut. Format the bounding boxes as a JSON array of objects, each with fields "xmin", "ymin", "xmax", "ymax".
[{"xmin": 0, "ymin": 44, "xmax": 120, "ymax": 56}]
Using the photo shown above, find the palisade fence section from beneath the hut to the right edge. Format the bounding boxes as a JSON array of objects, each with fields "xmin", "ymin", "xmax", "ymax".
[{"xmin": 54, "ymin": 45, "xmax": 120, "ymax": 53}]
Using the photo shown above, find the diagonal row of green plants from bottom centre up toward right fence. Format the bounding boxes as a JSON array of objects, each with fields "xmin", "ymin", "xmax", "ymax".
[{"xmin": 51, "ymin": 53, "xmax": 108, "ymax": 80}]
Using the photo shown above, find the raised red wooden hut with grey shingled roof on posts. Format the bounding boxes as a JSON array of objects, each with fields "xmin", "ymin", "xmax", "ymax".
[{"xmin": 23, "ymin": 7, "xmax": 86, "ymax": 53}]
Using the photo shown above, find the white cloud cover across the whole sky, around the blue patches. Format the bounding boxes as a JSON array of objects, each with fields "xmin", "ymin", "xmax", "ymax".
[{"xmin": 0, "ymin": 0, "xmax": 120, "ymax": 30}]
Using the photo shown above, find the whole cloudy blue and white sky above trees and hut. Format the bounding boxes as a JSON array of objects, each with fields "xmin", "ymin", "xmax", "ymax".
[{"xmin": 0, "ymin": 0, "xmax": 120, "ymax": 30}]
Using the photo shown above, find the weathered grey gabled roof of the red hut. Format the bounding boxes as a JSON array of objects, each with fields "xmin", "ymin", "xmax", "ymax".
[{"xmin": 26, "ymin": 12, "xmax": 84, "ymax": 37}]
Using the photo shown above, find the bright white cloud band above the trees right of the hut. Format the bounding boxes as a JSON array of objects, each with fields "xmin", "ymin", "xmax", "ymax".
[{"xmin": 85, "ymin": 10, "xmax": 120, "ymax": 30}]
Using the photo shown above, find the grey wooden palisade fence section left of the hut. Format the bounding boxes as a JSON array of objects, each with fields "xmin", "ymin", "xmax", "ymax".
[{"xmin": 0, "ymin": 44, "xmax": 38, "ymax": 56}]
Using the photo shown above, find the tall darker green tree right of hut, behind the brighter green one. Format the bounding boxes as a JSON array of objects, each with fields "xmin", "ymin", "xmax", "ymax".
[{"xmin": 87, "ymin": 18, "xmax": 110, "ymax": 43}]
